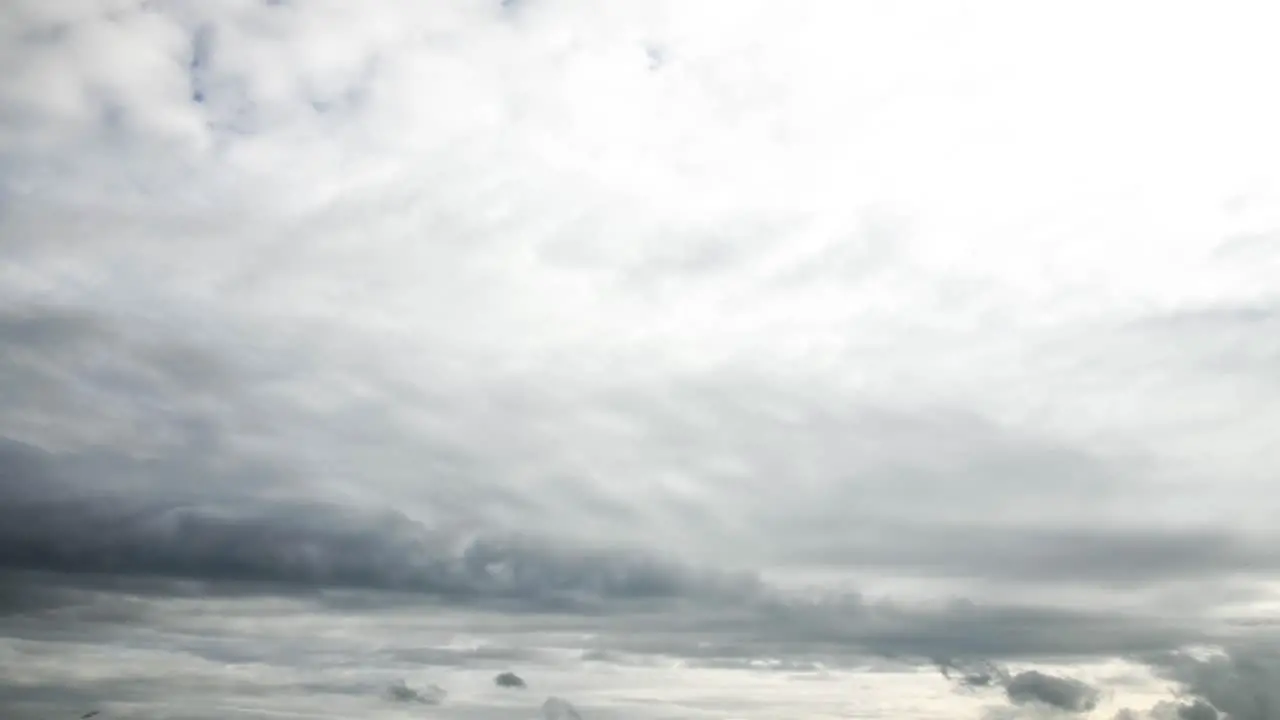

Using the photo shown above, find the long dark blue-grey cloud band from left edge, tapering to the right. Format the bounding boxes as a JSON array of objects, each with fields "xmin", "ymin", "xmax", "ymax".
[{"xmin": 0, "ymin": 443, "xmax": 1212, "ymax": 659}]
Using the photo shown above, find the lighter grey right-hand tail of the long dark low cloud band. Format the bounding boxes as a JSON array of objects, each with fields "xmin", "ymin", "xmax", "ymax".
[{"xmin": 588, "ymin": 593, "xmax": 1198, "ymax": 666}]
